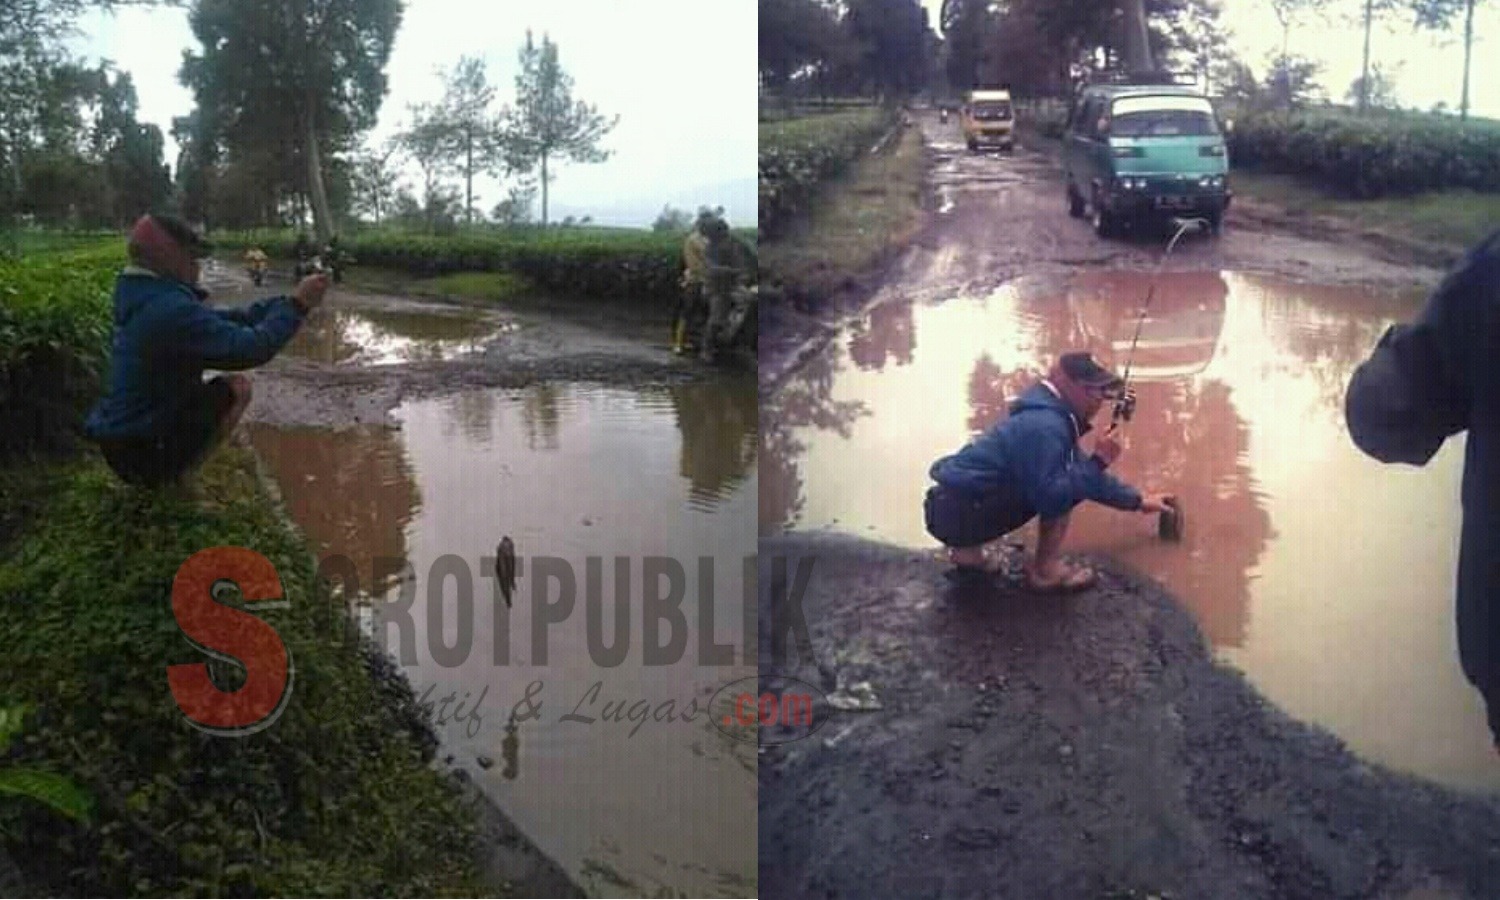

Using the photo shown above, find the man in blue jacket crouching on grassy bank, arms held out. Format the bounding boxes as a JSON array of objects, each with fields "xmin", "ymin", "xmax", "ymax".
[{"xmin": 86, "ymin": 215, "xmax": 327, "ymax": 486}]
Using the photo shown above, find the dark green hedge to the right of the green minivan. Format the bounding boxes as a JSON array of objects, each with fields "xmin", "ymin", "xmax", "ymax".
[{"xmin": 1229, "ymin": 113, "xmax": 1500, "ymax": 198}]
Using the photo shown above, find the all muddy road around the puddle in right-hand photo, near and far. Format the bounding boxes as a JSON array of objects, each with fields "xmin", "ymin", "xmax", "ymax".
[{"xmin": 759, "ymin": 117, "xmax": 1500, "ymax": 899}]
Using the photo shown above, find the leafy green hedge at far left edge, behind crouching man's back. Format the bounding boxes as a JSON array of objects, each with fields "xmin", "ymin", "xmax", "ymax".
[{"xmin": 0, "ymin": 240, "xmax": 126, "ymax": 459}]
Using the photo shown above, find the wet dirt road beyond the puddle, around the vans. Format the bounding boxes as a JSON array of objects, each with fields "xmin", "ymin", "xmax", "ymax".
[{"xmin": 761, "ymin": 113, "xmax": 1440, "ymax": 387}]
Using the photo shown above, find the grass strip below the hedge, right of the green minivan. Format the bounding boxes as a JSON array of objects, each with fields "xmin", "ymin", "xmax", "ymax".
[{"xmin": 1230, "ymin": 170, "xmax": 1500, "ymax": 251}]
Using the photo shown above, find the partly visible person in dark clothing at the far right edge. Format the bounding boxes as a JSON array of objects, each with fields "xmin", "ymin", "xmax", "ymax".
[{"xmin": 1344, "ymin": 231, "xmax": 1500, "ymax": 753}]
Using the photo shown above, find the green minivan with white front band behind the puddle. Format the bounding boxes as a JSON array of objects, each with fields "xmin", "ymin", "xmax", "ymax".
[{"xmin": 1064, "ymin": 84, "xmax": 1233, "ymax": 237}]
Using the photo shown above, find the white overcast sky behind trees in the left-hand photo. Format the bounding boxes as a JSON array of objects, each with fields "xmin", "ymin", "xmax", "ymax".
[{"xmin": 74, "ymin": 0, "xmax": 758, "ymax": 227}]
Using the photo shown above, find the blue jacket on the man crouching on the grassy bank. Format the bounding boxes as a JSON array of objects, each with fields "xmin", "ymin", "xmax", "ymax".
[{"xmin": 84, "ymin": 267, "xmax": 303, "ymax": 440}]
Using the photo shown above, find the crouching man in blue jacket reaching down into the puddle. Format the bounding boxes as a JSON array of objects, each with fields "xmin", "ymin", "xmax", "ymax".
[{"xmin": 924, "ymin": 353, "xmax": 1170, "ymax": 591}]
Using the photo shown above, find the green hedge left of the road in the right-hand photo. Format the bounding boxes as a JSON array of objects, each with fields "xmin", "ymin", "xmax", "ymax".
[{"xmin": 759, "ymin": 107, "xmax": 897, "ymax": 236}]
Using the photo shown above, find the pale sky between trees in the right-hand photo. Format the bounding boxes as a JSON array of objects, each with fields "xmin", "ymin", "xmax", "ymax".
[{"xmin": 923, "ymin": 0, "xmax": 1500, "ymax": 119}]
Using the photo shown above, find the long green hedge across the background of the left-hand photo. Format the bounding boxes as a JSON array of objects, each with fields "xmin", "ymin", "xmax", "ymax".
[{"xmin": 213, "ymin": 228, "xmax": 723, "ymax": 306}]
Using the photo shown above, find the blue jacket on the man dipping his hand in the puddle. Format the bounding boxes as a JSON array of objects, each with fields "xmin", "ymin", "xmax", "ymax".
[{"xmin": 930, "ymin": 384, "xmax": 1142, "ymax": 519}]
